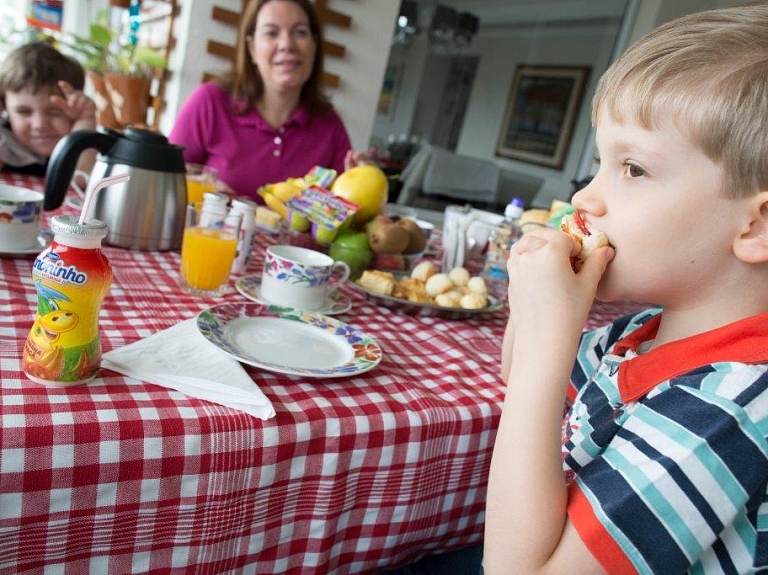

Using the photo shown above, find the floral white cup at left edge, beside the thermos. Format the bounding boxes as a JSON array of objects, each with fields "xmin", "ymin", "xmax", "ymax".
[{"xmin": 0, "ymin": 184, "xmax": 43, "ymax": 251}]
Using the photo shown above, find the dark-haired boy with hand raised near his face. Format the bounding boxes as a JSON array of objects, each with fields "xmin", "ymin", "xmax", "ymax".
[{"xmin": 0, "ymin": 42, "xmax": 96, "ymax": 176}]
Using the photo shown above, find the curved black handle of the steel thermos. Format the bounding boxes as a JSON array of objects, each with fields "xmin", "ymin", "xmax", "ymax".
[{"xmin": 43, "ymin": 130, "xmax": 117, "ymax": 210}]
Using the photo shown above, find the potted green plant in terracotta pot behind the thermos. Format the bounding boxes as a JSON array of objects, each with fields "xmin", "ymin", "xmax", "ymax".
[{"xmin": 40, "ymin": 11, "xmax": 167, "ymax": 128}]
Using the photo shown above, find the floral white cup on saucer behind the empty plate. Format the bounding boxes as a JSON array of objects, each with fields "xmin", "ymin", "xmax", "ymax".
[{"xmin": 261, "ymin": 246, "xmax": 349, "ymax": 310}]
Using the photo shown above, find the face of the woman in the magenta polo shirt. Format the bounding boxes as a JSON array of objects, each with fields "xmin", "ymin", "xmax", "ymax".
[{"xmin": 248, "ymin": 0, "xmax": 317, "ymax": 97}]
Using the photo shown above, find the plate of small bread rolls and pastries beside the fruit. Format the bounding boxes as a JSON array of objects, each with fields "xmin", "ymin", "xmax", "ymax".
[{"xmin": 350, "ymin": 261, "xmax": 503, "ymax": 319}]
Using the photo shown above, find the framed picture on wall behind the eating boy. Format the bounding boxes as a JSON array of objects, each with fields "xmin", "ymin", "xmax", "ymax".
[{"xmin": 496, "ymin": 65, "xmax": 591, "ymax": 169}]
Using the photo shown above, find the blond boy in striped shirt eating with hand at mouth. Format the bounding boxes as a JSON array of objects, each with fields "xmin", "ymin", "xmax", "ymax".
[{"xmin": 484, "ymin": 3, "xmax": 768, "ymax": 574}]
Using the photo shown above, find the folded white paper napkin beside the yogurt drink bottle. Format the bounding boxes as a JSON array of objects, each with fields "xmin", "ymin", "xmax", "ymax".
[{"xmin": 101, "ymin": 318, "xmax": 275, "ymax": 419}]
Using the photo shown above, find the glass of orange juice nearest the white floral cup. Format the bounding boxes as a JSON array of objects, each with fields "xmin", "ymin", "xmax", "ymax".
[{"xmin": 180, "ymin": 202, "xmax": 243, "ymax": 297}]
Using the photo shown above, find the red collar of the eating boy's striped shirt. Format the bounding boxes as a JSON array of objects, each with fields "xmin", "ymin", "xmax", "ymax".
[{"xmin": 610, "ymin": 312, "xmax": 768, "ymax": 404}]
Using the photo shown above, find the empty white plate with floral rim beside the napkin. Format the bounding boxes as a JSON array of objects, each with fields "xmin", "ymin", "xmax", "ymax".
[{"xmin": 197, "ymin": 302, "xmax": 381, "ymax": 378}]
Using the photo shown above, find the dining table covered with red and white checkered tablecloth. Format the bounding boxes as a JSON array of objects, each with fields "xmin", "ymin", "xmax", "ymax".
[{"xmin": 0, "ymin": 174, "xmax": 648, "ymax": 573}]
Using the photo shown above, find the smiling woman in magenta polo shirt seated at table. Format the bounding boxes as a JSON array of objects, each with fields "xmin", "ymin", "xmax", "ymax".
[{"xmin": 169, "ymin": 0, "xmax": 359, "ymax": 203}]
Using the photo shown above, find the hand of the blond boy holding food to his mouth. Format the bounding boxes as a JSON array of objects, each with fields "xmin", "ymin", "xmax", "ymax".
[{"xmin": 507, "ymin": 228, "xmax": 614, "ymax": 345}]
